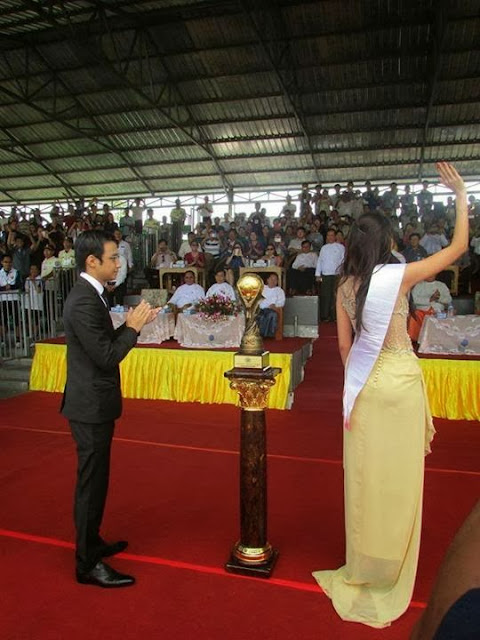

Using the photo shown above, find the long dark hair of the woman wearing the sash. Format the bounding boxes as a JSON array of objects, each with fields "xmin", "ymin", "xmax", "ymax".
[{"xmin": 340, "ymin": 211, "xmax": 398, "ymax": 334}]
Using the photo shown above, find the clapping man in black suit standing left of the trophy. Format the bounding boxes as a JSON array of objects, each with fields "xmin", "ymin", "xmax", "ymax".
[{"xmin": 61, "ymin": 231, "xmax": 157, "ymax": 587}]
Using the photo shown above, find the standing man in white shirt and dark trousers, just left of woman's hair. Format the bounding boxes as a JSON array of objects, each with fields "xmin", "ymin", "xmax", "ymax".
[{"xmin": 315, "ymin": 229, "xmax": 345, "ymax": 322}]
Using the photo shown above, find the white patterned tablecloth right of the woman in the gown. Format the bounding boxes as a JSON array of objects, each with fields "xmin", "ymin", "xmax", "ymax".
[{"xmin": 418, "ymin": 315, "xmax": 480, "ymax": 356}]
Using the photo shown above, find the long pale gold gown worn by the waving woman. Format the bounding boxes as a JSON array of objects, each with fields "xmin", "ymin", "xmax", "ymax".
[{"xmin": 313, "ymin": 282, "xmax": 434, "ymax": 627}]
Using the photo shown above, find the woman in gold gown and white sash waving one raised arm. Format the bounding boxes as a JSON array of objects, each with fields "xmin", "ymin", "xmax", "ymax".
[{"xmin": 313, "ymin": 163, "xmax": 468, "ymax": 627}]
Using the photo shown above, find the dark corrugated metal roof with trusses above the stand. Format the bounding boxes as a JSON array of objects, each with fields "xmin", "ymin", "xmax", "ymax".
[{"xmin": 0, "ymin": 0, "xmax": 480, "ymax": 201}]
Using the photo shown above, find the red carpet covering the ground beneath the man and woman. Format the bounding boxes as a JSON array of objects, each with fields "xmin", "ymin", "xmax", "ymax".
[{"xmin": 0, "ymin": 327, "xmax": 480, "ymax": 640}]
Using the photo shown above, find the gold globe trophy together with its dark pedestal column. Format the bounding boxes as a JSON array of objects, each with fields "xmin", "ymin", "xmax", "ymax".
[{"xmin": 225, "ymin": 273, "xmax": 281, "ymax": 578}]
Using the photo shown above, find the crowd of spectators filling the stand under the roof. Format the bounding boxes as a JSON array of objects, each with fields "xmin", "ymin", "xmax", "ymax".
[{"xmin": 0, "ymin": 181, "xmax": 480, "ymax": 342}]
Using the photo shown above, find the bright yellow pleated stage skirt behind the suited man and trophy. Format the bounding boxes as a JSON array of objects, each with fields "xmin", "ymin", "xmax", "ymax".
[{"xmin": 30, "ymin": 343, "xmax": 292, "ymax": 409}]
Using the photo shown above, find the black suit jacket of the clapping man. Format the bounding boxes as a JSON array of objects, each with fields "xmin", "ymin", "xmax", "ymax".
[{"xmin": 61, "ymin": 277, "xmax": 137, "ymax": 423}]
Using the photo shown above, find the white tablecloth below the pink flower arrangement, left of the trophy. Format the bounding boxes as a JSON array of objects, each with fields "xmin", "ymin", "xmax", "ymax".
[{"xmin": 173, "ymin": 313, "xmax": 245, "ymax": 349}]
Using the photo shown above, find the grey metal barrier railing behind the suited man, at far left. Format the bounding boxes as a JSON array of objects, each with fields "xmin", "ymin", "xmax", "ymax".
[{"xmin": 0, "ymin": 268, "xmax": 77, "ymax": 360}]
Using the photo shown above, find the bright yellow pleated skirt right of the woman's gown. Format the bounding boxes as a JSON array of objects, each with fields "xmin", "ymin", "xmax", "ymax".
[{"xmin": 419, "ymin": 358, "xmax": 480, "ymax": 420}]
